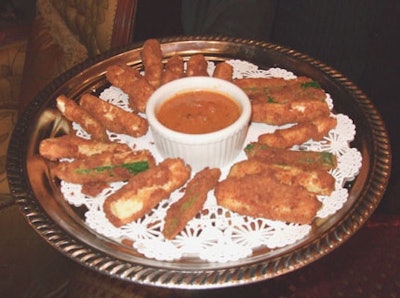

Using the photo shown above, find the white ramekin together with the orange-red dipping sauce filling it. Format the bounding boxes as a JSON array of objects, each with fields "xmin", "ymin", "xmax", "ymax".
[{"xmin": 146, "ymin": 77, "xmax": 251, "ymax": 171}]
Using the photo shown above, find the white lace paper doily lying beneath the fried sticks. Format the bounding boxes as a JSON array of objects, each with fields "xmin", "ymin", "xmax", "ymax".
[{"xmin": 61, "ymin": 60, "xmax": 361, "ymax": 262}]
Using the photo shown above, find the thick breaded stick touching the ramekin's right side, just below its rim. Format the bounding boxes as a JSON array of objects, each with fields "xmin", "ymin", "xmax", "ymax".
[{"xmin": 251, "ymin": 100, "xmax": 330, "ymax": 125}]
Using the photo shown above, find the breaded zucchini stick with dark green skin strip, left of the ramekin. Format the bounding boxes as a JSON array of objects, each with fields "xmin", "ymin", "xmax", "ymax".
[{"xmin": 53, "ymin": 150, "xmax": 155, "ymax": 184}]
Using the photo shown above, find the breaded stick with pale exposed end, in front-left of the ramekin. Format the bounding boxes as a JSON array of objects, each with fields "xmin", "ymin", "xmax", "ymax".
[{"xmin": 103, "ymin": 158, "xmax": 191, "ymax": 227}]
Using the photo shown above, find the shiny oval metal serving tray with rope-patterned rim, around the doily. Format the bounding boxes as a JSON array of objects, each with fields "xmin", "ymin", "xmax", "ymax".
[{"xmin": 7, "ymin": 37, "xmax": 391, "ymax": 289}]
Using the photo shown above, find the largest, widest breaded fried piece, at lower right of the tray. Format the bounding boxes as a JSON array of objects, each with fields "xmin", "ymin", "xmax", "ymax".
[{"xmin": 215, "ymin": 174, "xmax": 321, "ymax": 224}]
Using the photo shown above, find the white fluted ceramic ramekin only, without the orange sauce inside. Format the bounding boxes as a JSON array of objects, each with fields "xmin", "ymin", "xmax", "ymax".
[{"xmin": 146, "ymin": 76, "xmax": 251, "ymax": 171}]
